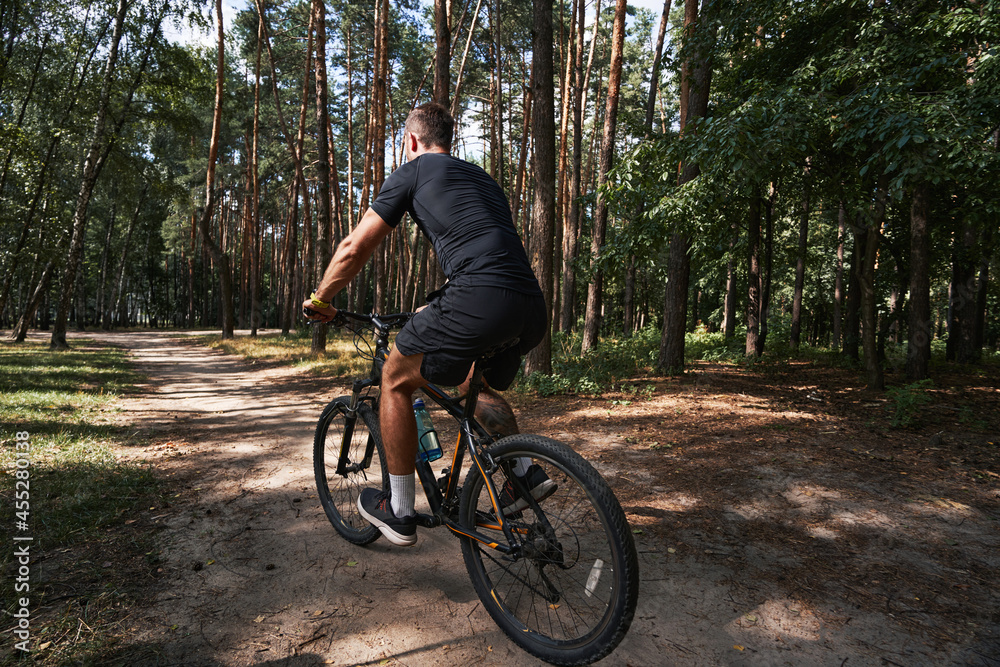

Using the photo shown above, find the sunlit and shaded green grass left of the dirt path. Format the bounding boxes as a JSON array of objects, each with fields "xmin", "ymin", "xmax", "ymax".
[{"xmin": 0, "ymin": 341, "xmax": 161, "ymax": 665}]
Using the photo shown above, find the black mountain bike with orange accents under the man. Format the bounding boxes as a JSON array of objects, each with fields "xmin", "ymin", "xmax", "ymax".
[{"xmin": 313, "ymin": 310, "xmax": 639, "ymax": 665}]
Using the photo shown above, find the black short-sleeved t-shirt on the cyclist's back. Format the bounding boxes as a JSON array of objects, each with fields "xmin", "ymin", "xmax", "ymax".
[{"xmin": 372, "ymin": 153, "xmax": 540, "ymax": 294}]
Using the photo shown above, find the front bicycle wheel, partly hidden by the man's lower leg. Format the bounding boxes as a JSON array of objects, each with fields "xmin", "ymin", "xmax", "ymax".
[{"xmin": 313, "ymin": 396, "xmax": 389, "ymax": 544}]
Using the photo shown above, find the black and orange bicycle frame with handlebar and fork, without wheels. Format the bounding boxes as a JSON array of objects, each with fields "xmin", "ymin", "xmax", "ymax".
[{"xmin": 337, "ymin": 311, "xmax": 532, "ymax": 557}]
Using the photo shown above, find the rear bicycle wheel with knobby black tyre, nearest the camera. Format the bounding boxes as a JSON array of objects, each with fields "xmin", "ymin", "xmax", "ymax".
[{"xmin": 460, "ymin": 435, "xmax": 639, "ymax": 665}]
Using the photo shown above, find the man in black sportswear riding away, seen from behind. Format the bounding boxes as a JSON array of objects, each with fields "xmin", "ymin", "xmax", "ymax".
[{"xmin": 303, "ymin": 103, "xmax": 555, "ymax": 546}]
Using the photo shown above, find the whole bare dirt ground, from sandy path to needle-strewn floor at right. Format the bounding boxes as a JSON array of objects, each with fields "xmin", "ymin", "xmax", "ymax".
[{"xmin": 9, "ymin": 331, "xmax": 1000, "ymax": 667}]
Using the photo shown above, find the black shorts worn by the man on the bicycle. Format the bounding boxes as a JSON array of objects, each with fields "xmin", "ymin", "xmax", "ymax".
[{"xmin": 395, "ymin": 283, "xmax": 548, "ymax": 390}]
